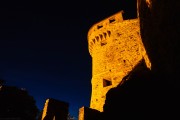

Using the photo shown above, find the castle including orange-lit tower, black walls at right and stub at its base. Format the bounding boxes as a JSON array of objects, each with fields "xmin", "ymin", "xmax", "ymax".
[{"xmin": 40, "ymin": 0, "xmax": 180, "ymax": 120}]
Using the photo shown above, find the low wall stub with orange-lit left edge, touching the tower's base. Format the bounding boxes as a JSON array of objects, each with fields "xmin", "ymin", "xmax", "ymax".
[{"xmin": 78, "ymin": 106, "xmax": 102, "ymax": 120}]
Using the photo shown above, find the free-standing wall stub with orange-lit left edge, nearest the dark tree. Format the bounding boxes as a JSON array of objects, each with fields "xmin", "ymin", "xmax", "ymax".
[{"xmin": 41, "ymin": 98, "xmax": 69, "ymax": 120}]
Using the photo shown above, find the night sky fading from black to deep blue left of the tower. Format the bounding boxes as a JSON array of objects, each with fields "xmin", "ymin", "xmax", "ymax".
[{"xmin": 0, "ymin": 0, "xmax": 136, "ymax": 117}]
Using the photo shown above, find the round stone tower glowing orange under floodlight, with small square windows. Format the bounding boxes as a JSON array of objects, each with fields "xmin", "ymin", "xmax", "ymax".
[{"xmin": 88, "ymin": 11, "xmax": 151, "ymax": 112}]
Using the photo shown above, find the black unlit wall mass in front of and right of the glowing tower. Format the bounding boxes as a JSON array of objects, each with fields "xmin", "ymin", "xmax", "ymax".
[{"xmin": 103, "ymin": 0, "xmax": 180, "ymax": 120}]
